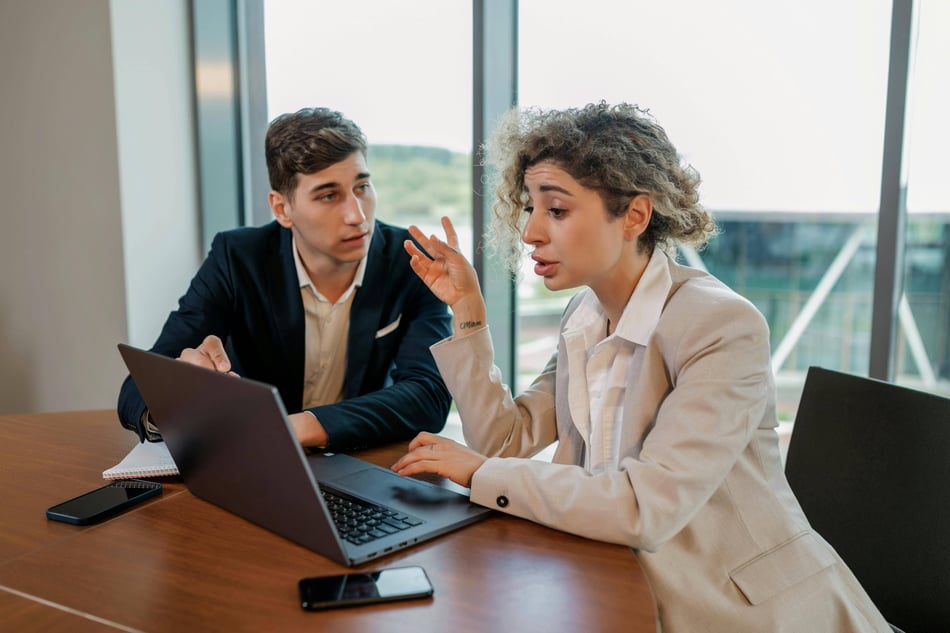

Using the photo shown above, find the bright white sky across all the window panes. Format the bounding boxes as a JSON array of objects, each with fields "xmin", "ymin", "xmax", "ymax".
[{"xmin": 265, "ymin": 0, "xmax": 950, "ymax": 211}]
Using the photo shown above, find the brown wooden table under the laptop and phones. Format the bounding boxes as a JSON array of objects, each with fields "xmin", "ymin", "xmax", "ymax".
[{"xmin": 0, "ymin": 411, "xmax": 655, "ymax": 633}]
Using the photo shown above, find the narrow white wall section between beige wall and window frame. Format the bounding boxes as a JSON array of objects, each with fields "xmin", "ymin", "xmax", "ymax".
[{"xmin": 111, "ymin": 0, "xmax": 201, "ymax": 347}]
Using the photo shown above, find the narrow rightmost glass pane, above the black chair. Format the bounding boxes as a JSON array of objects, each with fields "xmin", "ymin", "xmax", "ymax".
[{"xmin": 896, "ymin": 0, "xmax": 950, "ymax": 396}]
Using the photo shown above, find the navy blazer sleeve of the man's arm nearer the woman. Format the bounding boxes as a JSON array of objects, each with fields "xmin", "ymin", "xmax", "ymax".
[{"xmin": 309, "ymin": 266, "xmax": 452, "ymax": 450}]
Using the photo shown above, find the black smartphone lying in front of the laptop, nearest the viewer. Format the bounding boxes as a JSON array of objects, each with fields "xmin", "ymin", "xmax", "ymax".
[{"xmin": 299, "ymin": 566, "xmax": 432, "ymax": 611}]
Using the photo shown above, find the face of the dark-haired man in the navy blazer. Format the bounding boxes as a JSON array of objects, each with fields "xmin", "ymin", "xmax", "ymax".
[{"xmin": 270, "ymin": 152, "xmax": 376, "ymax": 272}]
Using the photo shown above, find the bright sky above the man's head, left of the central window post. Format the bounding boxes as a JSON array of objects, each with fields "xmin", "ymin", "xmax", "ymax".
[{"xmin": 265, "ymin": 0, "xmax": 472, "ymax": 152}]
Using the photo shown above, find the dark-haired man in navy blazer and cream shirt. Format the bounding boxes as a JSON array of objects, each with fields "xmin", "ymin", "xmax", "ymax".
[{"xmin": 118, "ymin": 108, "xmax": 451, "ymax": 450}]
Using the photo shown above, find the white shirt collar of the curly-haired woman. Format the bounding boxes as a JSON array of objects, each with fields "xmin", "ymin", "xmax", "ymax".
[{"xmin": 564, "ymin": 248, "xmax": 673, "ymax": 345}]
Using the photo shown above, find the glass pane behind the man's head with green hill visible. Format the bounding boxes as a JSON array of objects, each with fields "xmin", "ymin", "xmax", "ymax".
[{"xmin": 264, "ymin": 0, "xmax": 472, "ymax": 256}]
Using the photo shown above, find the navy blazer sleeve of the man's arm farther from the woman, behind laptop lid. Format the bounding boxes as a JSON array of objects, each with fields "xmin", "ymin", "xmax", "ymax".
[{"xmin": 117, "ymin": 234, "xmax": 234, "ymax": 441}]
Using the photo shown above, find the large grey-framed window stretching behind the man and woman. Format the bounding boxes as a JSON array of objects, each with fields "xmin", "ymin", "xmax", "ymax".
[{"xmin": 203, "ymin": 0, "xmax": 950, "ymax": 444}]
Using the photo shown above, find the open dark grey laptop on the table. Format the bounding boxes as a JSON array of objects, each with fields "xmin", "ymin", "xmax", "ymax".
[{"xmin": 118, "ymin": 343, "xmax": 492, "ymax": 566}]
